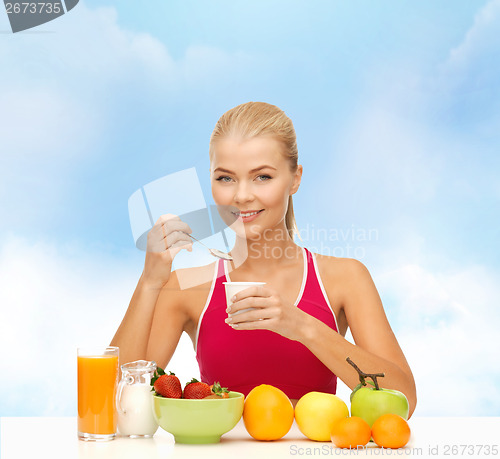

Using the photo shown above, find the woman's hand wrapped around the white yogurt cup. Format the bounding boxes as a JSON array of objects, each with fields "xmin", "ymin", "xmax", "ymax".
[{"xmin": 226, "ymin": 285, "xmax": 307, "ymax": 341}]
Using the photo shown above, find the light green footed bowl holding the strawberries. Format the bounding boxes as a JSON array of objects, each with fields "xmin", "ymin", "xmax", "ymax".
[{"xmin": 153, "ymin": 392, "xmax": 245, "ymax": 444}]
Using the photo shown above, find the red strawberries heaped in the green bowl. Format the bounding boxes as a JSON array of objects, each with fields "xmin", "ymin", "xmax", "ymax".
[{"xmin": 151, "ymin": 368, "xmax": 229, "ymax": 400}]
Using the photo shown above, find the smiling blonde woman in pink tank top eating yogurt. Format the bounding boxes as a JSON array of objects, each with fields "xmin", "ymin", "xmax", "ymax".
[{"xmin": 111, "ymin": 102, "xmax": 416, "ymax": 415}]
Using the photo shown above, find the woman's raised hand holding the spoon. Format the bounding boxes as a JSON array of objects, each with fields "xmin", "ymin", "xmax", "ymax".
[{"xmin": 142, "ymin": 214, "xmax": 193, "ymax": 288}]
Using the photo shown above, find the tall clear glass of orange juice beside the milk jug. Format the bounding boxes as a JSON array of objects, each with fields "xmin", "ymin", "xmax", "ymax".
[{"xmin": 77, "ymin": 346, "xmax": 118, "ymax": 441}]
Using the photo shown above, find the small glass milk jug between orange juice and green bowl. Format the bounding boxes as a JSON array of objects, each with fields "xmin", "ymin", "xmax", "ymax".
[{"xmin": 116, "ymin": 360, "xmax": 158, "ymax": 438}]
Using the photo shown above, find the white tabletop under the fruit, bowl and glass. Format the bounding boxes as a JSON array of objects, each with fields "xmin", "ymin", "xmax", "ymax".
[{"xmin": 0, "ymin": 417, "xmax": 500, "ymax": 459}]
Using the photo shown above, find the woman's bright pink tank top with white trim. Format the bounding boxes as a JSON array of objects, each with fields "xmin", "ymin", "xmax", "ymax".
[{"xmin": 196, "ymin": 248, "xmax": 338, "ymax": 398}]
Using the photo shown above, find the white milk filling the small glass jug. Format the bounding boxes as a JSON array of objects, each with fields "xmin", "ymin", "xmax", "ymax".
[{"xmin": 116, "ymin": 384, "xmax": 158, "ymax": 437}]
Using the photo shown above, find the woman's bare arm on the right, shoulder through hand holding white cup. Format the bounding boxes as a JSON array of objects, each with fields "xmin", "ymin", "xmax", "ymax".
[{"xmin": 226, "ymin": 258, "xmax": 417, "ymax": 415}]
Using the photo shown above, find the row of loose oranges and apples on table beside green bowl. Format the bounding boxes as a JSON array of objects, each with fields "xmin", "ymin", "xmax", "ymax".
[{"xmin": 243, "ymin": 358, "xmax": 411, "ymax": 448}]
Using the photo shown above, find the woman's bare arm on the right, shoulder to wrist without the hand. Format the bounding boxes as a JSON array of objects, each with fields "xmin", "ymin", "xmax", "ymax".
[{"xmin": 298, "ymin": 259, "xmax": 417, "ymax": 416}]
